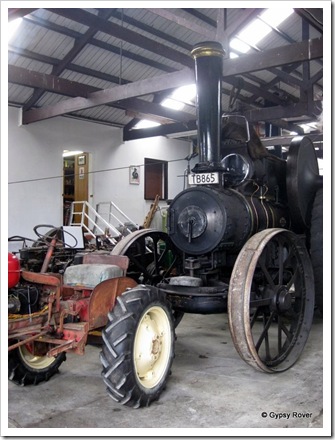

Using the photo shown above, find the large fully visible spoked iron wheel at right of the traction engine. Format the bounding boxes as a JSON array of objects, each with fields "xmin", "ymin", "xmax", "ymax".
[{"xmin": 228, "ymin": 229, "xmax": 314, "ymax": 373}]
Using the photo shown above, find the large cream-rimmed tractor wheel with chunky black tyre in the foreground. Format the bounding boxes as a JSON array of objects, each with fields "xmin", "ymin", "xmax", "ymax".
[{"xmin": 100, "ymin": 285, "xmax": 174, "ymax": 408}]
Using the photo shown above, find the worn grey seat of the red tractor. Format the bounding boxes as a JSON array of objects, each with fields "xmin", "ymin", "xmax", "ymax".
[{"xmin": 63, "ymin": 264, "xmax": 124, "ymax": 288}]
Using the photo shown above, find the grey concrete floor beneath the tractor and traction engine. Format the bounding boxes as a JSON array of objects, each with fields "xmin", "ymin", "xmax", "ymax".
[{"xmin": 2, "ymin": 314, "xmax": 330, "ymax": 436}]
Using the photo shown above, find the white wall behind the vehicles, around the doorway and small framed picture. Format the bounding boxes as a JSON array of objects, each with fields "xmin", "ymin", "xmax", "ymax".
[{"xmin": 8, "ymin": 107, "xmax": 190, "ymax": 250}]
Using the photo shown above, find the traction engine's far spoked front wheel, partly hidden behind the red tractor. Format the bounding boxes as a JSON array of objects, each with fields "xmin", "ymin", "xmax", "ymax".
[{"xmin": 112, "ymin": 229, "xmax": 181, "ymax": 286}]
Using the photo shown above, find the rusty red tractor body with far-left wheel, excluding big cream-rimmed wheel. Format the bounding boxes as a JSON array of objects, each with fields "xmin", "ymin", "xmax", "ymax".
[{"xmin": 8, "ymin": 237, "xmax": 136, "ymax": 385}]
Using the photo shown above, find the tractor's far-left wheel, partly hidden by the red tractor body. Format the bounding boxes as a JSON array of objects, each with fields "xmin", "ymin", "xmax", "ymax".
[{"xmin": 8, "ymin": 344, "xmax": 66, "ymax": 386}]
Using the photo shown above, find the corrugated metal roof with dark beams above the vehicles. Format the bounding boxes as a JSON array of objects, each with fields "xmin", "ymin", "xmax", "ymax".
[{"xmin": 8, "ymin": 5, "xmax": 323, "ymax": 138}]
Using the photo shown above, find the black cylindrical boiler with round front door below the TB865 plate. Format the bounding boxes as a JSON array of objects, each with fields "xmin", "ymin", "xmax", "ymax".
[{"xmin": 168, "ymin": 186, "xmax": 289, "ymax": 255}]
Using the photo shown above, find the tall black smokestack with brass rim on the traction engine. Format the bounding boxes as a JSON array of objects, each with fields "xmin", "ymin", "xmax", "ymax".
[{"xmin": 191, "ymin": 41, "xmax": 224, "ymax": 172}]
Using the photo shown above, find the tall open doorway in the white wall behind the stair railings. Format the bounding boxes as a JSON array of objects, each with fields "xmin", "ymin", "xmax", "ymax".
[{"xmin": 63, "ymin": 153, "xmax": 89, "ymax": 226}]
